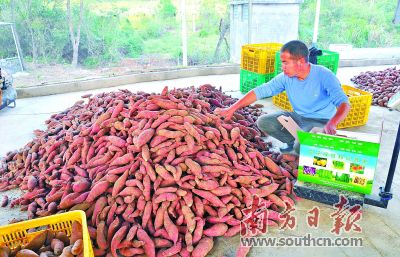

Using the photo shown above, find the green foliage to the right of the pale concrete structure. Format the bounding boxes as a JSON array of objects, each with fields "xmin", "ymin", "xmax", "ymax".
[{"xmin": 299, "ymin": 0, "xmax": 400, "ymax": 49}]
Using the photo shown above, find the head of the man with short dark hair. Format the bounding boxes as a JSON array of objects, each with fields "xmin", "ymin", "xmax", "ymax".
[{"xmin": 281, "ymin": 40, "xmax": 309, "ymax": 77}]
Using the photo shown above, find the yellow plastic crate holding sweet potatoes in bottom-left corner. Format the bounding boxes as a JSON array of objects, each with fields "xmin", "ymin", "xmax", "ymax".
[{"xmin": 0, "ymin": 211, "xmax": 94, "ymax": 257}]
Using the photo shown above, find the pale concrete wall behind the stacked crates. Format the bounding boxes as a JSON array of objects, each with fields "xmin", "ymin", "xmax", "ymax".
[{"xmin": 230, "ymin": 0, "xmax": 303, "ymax": 63}]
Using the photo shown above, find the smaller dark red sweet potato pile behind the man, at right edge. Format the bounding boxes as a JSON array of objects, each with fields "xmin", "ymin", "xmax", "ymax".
[{"xmin": 351, "ymin": 67, "xmax": 400, "ymax": 106}]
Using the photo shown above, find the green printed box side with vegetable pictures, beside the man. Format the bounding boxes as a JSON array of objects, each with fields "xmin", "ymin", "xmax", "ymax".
[{"xmin": 298, "ymin": 131, "xmax": 380, "ymax": 194}]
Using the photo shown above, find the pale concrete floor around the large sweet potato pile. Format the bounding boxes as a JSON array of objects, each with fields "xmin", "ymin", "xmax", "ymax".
[{"xmin": 0, "ymin": 66, "xmax": 400, "ymax": 257}]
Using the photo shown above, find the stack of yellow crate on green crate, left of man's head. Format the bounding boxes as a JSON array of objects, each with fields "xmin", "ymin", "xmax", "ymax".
[{"xmin": 240, "ymin": 43, "xmax": 282, "ymax": 93}]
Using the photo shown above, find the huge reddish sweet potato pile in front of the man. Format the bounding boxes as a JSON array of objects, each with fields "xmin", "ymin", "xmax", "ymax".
[{"xmin": 0, "ymin": 85, "xmax": 297, "ymax": 257}]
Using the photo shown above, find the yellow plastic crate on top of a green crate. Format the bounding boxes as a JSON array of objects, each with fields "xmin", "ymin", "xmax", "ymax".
[{"xmin": 240, "ymin": 43, "xmax": 282, "ymax": 74}]
